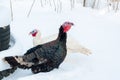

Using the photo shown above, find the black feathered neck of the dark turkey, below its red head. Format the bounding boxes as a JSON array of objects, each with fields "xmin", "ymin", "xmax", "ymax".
[{"xmin": 57, "ymin": 26, "xmax": 67, "ymax": 43}]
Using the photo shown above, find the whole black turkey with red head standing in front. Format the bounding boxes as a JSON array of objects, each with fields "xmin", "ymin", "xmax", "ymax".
[{"xmin": 4, "ymin": 22, "xmax": 73, "ymax": 73}]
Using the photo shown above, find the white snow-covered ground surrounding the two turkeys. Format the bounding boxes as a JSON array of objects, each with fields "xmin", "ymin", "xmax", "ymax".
[{"xmin": 0, "ymin": 0, "xmax": 120, "ymax": 80}]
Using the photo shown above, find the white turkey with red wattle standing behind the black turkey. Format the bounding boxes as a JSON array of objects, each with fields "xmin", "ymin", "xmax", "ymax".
[{"xmin": 29, "ymin": 29, "xmax": 91, "ymax": 55}]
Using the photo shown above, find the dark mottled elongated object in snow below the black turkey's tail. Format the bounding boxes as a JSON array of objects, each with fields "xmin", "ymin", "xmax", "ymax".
[{"xmin": 0, "ymin": 67, "xmax": 17, "ymax": 80}]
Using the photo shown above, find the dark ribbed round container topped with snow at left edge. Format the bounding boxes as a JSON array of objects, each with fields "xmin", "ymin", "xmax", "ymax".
[{"xmin": 0, "ymin": 25, "xmax": 10, "ymax": 51}]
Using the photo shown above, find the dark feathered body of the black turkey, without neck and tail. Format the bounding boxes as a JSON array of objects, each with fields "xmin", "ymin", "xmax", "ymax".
[{"xmin": 23, "ymin": 35, "xmax": 67, "ymax": 73}]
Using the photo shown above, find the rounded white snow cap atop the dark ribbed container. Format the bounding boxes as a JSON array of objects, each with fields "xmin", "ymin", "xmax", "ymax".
[{"xmin": 0, "ymin": 5, "xmax": 11, "ymax": 27}]
